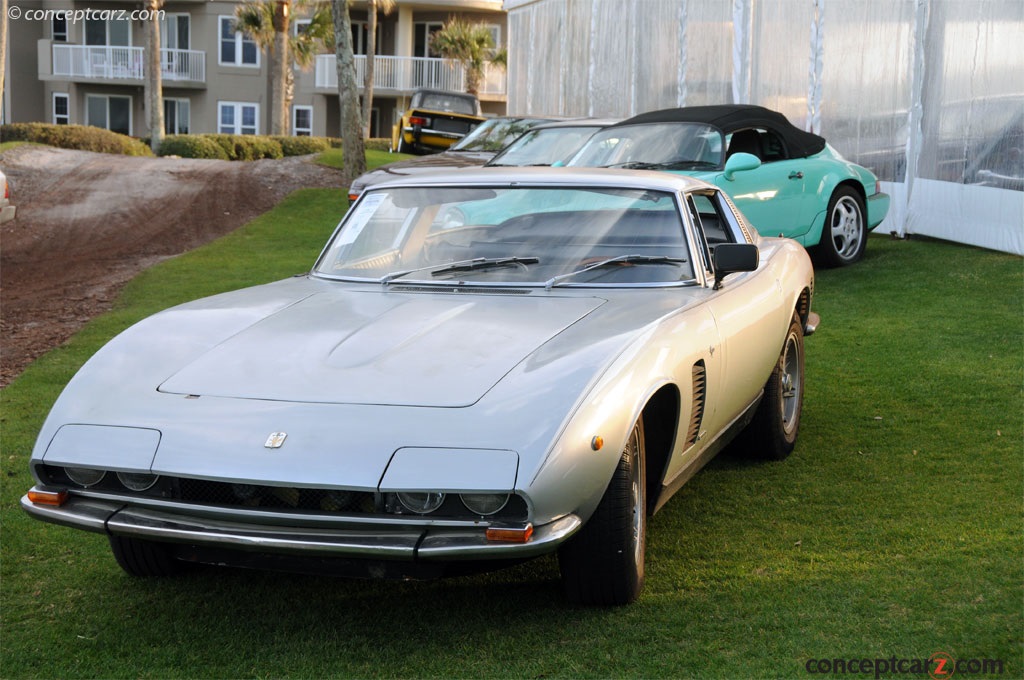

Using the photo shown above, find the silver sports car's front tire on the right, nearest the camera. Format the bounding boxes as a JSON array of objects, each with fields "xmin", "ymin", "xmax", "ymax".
[{"xmin": 558, "ymin": 419, "xmax": 647, "ymax": 605}]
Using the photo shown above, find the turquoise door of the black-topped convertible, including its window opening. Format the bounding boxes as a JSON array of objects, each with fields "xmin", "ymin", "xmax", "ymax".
[{"xmin": 715, "ymin": 128, "xmax": 816, "ymax": 240}]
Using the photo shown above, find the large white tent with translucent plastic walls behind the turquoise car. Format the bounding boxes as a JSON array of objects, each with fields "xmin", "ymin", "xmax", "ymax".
[{"xmin": 505, "ymin": 0, "xmax": 1024, "ymax": 254}]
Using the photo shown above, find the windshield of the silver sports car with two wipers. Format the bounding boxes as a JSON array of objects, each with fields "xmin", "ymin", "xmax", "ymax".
[{"xmin": 314, "ymin": 185, "xmax": 694, "ymax": 288}]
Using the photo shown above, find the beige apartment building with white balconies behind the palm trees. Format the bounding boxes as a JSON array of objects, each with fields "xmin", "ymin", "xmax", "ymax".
[{"xmin": 2, "ymin": 0, "xmax": 507, "ymax": 137}]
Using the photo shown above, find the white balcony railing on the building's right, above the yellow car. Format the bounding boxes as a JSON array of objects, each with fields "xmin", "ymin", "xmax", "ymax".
[{"xmin": 315, "ymin": 54, "xmax": 505, "ymax": 94}]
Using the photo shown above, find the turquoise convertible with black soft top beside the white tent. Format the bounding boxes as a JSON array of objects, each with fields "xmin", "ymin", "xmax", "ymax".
[{"xmin": 567, "ymin": 104, "xmax": 889, "ymax": 266}]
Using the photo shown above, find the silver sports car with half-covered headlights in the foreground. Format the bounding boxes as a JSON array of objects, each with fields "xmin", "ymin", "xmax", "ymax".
[{"xmin": 22, "ymin": 168, "xmax": 817, "ymax": 604}]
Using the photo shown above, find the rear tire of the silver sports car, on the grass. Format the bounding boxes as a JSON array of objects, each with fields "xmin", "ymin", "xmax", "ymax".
[{"xmin": 746, "ymin": 316, "xmax": 804, "ymax": 461}]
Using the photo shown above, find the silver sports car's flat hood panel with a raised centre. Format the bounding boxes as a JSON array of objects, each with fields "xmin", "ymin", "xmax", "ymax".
[{"xmin": 159, "ymin": 291, "xmax": 602, "ymax": 408}]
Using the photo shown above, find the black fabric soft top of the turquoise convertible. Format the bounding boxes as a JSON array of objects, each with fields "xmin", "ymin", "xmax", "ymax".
[{"xmin": 611, "ymin": 103, "xmax": 825, "ymax": 158}]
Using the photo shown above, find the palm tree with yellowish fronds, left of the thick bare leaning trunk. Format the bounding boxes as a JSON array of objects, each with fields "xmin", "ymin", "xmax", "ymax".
[{"xmin": 234, "ymin": 0, "xmax": 332, "ymax": 134}]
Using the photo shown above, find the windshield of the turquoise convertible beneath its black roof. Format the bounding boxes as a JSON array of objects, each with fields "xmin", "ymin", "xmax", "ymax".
[{"xmin": 567, "ymin": 123, "xmax": 725, "ymax": 170}]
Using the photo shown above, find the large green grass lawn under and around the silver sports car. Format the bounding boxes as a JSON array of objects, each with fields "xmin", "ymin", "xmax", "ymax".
[{"xmin": 0, "ymin": 189, "xmax": 1024, "ymax": 678}]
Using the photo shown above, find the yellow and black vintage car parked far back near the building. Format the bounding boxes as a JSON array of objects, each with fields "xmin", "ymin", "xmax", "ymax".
[{"xmin": 391, "ymin": 89, "xmax": 484, "ymax": 154}]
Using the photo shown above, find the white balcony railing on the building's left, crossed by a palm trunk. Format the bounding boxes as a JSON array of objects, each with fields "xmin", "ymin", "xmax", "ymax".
[{"xmin": 53, "ymin": 44, "xmax": 206, "ymax": 83}]
